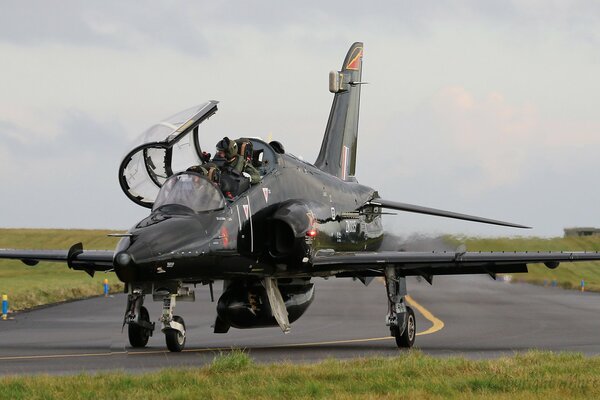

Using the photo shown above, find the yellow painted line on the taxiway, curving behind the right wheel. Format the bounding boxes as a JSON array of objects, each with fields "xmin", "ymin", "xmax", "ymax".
[{"xmin": 0, "ymin": 295, "xmax": 444, "ymax": 361}]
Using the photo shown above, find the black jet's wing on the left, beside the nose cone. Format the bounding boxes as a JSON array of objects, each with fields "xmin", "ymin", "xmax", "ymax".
[{"xmin": 0, "ymin": 243, "xmax": 114, "ymax": 276}]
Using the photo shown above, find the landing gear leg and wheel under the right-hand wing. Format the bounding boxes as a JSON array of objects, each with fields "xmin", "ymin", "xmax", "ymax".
[{"xmin": 385, "ymin": 267, "xmax": 417, "ymax": 348}]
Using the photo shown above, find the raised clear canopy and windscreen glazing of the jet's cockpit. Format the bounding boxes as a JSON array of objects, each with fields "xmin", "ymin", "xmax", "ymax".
[{"xmin": 119, "ymin": 100, "xmax": 282, "ymax": 212}]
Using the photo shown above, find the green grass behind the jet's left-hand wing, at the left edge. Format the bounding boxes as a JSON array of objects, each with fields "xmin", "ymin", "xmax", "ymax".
[{"xmin": 0, "ymin": 229, "xmax": 123, "ymax": 311}]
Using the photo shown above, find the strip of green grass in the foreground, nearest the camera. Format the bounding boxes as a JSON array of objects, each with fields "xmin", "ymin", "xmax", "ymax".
[{"xmin": 0, "ymin": 351, "xmax": 600, "ymax": 400}]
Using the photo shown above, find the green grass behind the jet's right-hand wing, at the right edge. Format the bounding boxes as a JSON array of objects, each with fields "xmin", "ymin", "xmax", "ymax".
[{"xmin": 445, "ymin": 236, "xmax": 600, "ymax": 292}]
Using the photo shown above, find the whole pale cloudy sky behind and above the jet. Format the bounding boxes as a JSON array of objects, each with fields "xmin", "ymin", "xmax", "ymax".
[{"xmin": 0, "ymin": 0, "xmax": 600, "ymax": 236}]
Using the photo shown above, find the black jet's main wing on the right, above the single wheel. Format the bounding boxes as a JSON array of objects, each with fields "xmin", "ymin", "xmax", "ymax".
[{"xmin": 312, "ymin": 251, "xmax": 600, "ymax": 283}]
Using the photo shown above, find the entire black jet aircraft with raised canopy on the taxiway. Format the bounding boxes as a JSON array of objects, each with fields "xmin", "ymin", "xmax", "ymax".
[{"xmin": 0, "ymin": 43, "xmax": 600, "ymax": 351}]
